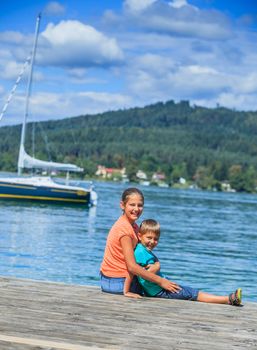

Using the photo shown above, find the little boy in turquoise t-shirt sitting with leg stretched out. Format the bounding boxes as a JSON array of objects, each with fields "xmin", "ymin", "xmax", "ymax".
[{"xmin": 124, "ymin": 219, "xmax": 242, "ymax": 306}]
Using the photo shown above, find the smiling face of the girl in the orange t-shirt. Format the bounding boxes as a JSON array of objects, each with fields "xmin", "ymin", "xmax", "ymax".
[{"xmin": 120, "ymin": 193, "xmax": 144, "ymax": 224}]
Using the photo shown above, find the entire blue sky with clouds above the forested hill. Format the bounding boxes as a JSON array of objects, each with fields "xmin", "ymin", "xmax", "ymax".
[{"xmin": 0, "ymin": 0, "xmax": 257, "ymax": 126}]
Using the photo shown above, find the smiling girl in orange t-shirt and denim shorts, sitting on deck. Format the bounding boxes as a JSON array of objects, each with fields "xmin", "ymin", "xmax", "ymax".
[{"xmin": 101, "ymin": 188, "xmax": 180, "ymax": 298}]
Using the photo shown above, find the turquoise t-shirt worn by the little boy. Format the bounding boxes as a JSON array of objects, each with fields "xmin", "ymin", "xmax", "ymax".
[{"xmin": 134, "ymin": 243, "xmax": 162, "ymax": 297}]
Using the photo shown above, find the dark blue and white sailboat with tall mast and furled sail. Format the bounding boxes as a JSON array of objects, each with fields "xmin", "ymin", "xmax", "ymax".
[{"xmin": 0, "ymin": 14, "xmax": 97, "ymax": 206}]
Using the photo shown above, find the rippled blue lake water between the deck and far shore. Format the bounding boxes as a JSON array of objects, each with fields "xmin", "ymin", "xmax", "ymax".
[{"xmin": 0, "ymin": 182, "xmax": 257, "ymax": 302}]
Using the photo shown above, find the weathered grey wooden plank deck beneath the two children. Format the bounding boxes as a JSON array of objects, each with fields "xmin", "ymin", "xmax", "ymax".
[{"xmin": 0, "ymin": 278, "xmax": 257, "ymax": 350}]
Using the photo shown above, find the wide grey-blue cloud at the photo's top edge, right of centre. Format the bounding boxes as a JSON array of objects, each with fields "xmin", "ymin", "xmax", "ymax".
[{"xmin": 118, "ymin": 0, "xmax": 233, "ymax": 40}]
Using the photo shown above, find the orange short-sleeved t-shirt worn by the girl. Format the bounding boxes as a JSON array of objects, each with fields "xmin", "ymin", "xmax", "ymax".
[{"xmin": 101, "ymin": 215, "xmax": 138, "ymax": 277}]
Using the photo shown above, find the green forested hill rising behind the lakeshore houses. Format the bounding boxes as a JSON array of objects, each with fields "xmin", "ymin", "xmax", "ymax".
[{"xmin": 0, "ymin": 101, "xmax": 257, "ymax": 191}]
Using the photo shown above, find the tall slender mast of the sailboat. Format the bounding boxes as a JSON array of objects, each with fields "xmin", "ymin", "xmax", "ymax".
[{"xmin": 18, "ymin": 14, "xmax": 41, "ymax": 175}]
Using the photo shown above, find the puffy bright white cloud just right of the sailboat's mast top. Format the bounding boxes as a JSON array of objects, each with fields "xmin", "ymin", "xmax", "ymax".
[{"xmin": 39, "ymin": 21, "xmax": 123, "ymax": 68}]
